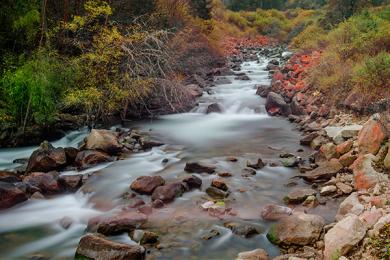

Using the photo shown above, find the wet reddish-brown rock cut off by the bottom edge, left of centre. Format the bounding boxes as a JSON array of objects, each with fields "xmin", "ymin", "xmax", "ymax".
[{"xmin": 75, "ymin": 234, "xmax": 146, "ymax": 260}]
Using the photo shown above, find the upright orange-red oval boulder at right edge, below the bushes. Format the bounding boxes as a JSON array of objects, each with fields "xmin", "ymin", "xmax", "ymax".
[{"xmin": 357, "ymin": 114, "xmax": 386, "ymax": 155}]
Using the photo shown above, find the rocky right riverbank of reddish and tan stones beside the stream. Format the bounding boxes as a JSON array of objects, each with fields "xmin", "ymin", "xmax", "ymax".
[{"xmin": 254, "ymin": 49, "xmax": 390, "ymax": 260}]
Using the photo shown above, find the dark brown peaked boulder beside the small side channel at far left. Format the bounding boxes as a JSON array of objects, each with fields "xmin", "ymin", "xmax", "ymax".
[{"xmin": 26, "ymin": 141, "xmax": 66, "ymax": 172}]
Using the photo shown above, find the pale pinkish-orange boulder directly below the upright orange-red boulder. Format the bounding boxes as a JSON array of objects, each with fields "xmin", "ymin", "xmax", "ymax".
[{"xmin": 350, "ymin": 154, "xmax": 388, "ymax": 190}]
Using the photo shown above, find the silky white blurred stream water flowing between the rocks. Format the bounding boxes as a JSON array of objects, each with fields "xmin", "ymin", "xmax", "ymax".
[{"xmin": 0, "ymin": 54, "xmax": 335, "ymax": 259}]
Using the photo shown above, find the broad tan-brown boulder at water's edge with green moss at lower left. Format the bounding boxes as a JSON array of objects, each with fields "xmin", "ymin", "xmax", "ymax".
[{"xmin": 267, "ymin": 212, "xmax": 325, "ymax": 246}]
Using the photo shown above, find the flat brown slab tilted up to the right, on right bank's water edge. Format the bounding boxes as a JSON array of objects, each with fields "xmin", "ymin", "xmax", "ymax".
[{"xmin": 301, "ymin": 159, "xmax": 343, "ymax": 181}]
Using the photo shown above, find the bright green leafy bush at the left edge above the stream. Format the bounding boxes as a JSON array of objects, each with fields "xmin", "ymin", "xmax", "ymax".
[{"xmin": 1, "ymin": 50, "xmax": 75, "ymax": 126}]
